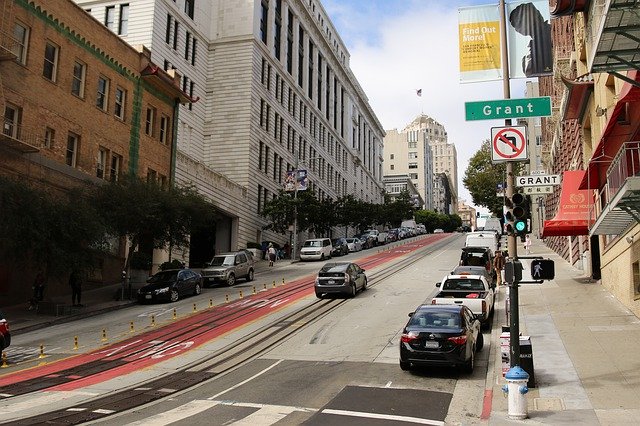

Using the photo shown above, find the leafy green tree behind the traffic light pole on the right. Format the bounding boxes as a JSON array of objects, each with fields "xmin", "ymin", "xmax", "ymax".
[{"xmin": 462, "ymin": 139, "xmax": 521, "ymax": 217}]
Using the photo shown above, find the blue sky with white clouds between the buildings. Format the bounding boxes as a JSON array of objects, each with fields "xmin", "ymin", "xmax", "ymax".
[{"xmin": 322, "ymin": 0, "xmax": 526, "ymax": 212}]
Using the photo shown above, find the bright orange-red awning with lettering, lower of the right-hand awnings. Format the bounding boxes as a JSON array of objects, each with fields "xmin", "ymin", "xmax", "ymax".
[{"xmin": 542, "ymin": 170, "xmax": 590, "ymax": 238}]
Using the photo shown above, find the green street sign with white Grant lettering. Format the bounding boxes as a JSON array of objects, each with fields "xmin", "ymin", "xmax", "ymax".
[{"xmin": 464, "ymin": 96, "xmax": 551, "ymax": 121}]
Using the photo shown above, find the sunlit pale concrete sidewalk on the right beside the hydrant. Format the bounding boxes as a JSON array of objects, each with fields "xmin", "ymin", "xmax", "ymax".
[{"xmin": 486, "ymin": 239, "xmax": 640, "ymax": 425}]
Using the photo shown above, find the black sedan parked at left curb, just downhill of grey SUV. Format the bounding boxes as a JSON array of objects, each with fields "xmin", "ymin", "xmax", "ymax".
[{"xmin": 138, "ymin": 269, "xmax": 202, "ymax": 303}]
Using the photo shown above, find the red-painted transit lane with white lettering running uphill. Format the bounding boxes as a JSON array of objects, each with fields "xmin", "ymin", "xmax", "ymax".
[{"xmin": 0, "ymin": 234, "xmax": 446, "ymax": 391}]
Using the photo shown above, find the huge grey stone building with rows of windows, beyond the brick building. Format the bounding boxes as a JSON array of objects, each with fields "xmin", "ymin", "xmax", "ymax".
[{"xmin": 75, "ymin": 0, "xmax": 384, "ymax": 260}]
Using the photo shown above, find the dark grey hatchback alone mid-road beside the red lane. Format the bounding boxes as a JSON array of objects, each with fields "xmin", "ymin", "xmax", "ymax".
[{"xmin": 315, "ymin": 262, "xmax": 367, "ymax": 299}]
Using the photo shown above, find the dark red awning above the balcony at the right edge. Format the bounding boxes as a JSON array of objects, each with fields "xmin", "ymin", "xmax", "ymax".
[{"xmin": 580, "ymin": 71, "xmax": 640, "ymax": 189}]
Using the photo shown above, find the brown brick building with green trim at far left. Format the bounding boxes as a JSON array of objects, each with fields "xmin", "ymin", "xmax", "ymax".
[{"xmin": 0, "ymin": 0, "xmax": 189, "ymax": 300}]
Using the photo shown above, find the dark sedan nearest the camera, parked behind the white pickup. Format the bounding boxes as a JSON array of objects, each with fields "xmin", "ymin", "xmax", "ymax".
[{"xmin": 400, "ymin": 305, "xmax": 484, "ymax": 373}]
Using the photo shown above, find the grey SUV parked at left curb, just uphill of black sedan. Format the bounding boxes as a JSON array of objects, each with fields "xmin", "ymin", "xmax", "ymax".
[{"xmin": 202, "ymin": 250, "xmax": 254, "ymax": 287}]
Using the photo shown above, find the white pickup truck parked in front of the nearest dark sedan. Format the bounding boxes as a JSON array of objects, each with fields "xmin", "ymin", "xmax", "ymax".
[{"xmin": 431, "ymin": 274, "xmax": 495, "ymax": 326}]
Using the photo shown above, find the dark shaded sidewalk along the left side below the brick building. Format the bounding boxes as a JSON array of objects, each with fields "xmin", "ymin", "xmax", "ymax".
[{"xmin": 1, "ymin": 260, "xmax": 282, "ymax": 335}]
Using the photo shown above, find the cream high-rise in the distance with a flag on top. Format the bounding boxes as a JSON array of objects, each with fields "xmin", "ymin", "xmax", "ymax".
[{"xmin": 384, "ymin": 114, "xmax": 458, "ymax": 213}]
